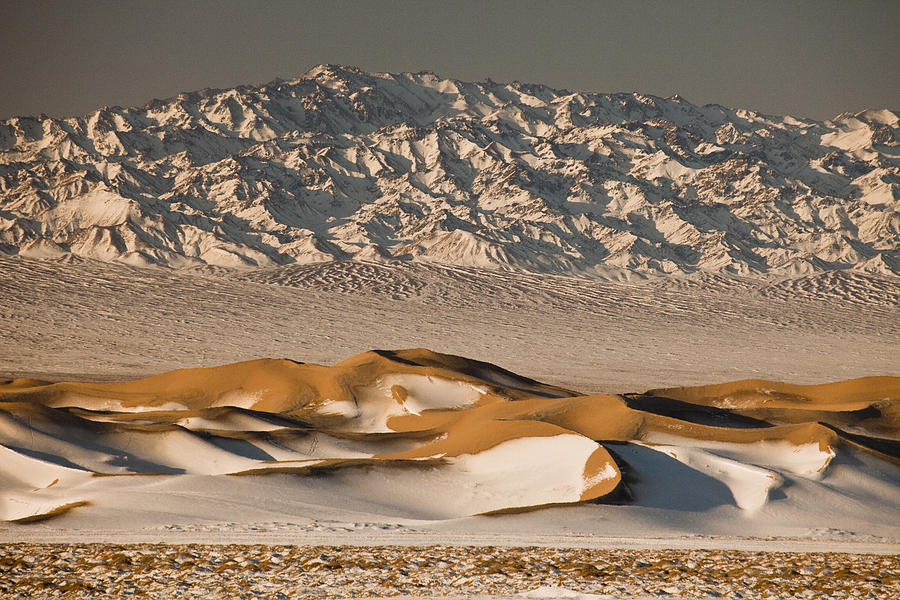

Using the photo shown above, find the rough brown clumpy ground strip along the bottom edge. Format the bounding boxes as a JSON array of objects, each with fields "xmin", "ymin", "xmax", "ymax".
[{"xmin": 0, "ymin": 544, "xmax": 900, "ymax": 599}]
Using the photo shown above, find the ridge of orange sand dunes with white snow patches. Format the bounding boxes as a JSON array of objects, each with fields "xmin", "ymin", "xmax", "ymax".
[{"xmin": 0, "ymin": 349, "xmax": 900, "ymax": 522}]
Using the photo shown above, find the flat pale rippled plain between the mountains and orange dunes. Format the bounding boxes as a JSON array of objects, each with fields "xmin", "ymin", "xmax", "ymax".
[{"xmin": 0, "ymin": 255, "xmax": 900, "ymax": 392}]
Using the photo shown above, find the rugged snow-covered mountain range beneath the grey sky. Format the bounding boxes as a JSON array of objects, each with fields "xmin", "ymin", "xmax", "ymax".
[{"xmin": 0, "ymin": 66, "xmax": 900, "ymax": 276}]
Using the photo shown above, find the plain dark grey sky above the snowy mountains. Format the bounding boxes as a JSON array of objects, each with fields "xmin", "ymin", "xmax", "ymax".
[{"xmin": 0, "ymin": 0, "xmax": 900, "ymax": 119}]
